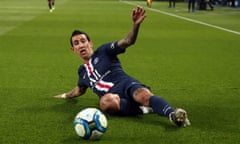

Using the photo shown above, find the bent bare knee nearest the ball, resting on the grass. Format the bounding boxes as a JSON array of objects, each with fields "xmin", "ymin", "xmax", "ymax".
[{"xmin": 99, "ymin": 93, "xmax": 120, "ymax": 113}]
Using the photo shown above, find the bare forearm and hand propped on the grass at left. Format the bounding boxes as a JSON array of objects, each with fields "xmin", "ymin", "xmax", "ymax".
[{"xmin": 54, "ymin": 86, "xmax": 86, "ymax": 99}]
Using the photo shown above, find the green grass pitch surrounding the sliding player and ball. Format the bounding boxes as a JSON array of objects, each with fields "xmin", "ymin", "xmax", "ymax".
[{"xmin": 0, "ymin": 0, "xmax": 240, "ymax": 144}]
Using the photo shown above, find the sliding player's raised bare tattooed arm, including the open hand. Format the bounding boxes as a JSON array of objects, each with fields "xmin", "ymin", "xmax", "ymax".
[{"xmin": 118, "ymin": 6, "xmax": 146, "ymax": 48}]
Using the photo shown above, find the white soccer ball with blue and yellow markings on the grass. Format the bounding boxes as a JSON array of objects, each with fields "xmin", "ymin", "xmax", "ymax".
[{"xmin": 73, "ymin": 108, "xmax": 107, "ymax": 140}]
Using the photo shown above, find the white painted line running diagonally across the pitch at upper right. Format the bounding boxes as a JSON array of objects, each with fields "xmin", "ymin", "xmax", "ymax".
[{"xmin": 120, "ymin": 0, "xmax": 240, "ymax": 35}]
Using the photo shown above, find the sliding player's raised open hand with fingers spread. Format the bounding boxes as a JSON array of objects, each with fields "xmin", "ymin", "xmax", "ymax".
[{"xmin": 132, "ymin": 6, "xmax": 146, "ymax": 24}]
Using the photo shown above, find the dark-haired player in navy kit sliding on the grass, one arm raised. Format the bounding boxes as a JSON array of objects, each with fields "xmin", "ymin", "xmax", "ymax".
[{"xmin": 54, "ymin": 7, "xmax": 190, "ymax": 127}]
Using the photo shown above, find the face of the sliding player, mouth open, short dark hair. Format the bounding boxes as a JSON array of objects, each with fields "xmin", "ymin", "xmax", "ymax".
[{"xmin": 72, "ymin": 34, "xmax": 93, "ymax": 62}]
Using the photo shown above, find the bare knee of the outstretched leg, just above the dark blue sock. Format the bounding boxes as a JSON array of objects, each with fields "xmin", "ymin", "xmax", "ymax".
[{"xmin": 133, "ymin": 88, "xmax": 153, "ymax": 106}]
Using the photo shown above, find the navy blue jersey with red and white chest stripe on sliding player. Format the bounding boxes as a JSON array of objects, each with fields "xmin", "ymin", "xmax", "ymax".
[{"xmin": 78, "ymin": 42, "xmax": 144, "ymax": 98}]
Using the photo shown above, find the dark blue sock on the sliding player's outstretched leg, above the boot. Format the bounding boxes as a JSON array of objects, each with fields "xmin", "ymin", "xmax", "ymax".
[{"xmin": 149, "ymin": 96, "xmax": 174, "ymax": 117}]
